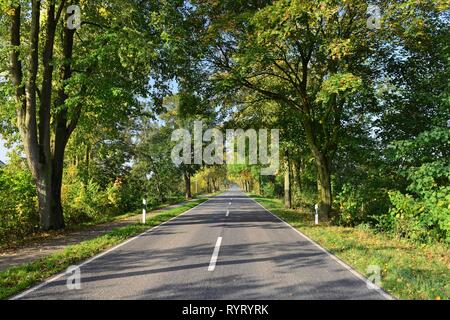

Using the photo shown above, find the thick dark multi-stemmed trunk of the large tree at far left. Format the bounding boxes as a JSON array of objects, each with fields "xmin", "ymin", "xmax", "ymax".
[{"xmin": 10, "ymin": 0, "xmax": 81, "ymax": 230}]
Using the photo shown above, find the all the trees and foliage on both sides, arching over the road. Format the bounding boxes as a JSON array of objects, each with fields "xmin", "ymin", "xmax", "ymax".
[{"xmin": 0, "ymin": 0, "xmax": 450, "ymax": 243}]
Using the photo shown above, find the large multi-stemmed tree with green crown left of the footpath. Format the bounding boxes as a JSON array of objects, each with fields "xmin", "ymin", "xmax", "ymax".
[{"xmin": 1, "ymin": 0, "xmax": 167, "ymax": 230}]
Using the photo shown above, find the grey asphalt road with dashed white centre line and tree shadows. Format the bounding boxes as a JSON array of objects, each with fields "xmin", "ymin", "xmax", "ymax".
[{"xmin": 10, "ymin": 190, "xmax": 389, "ymax": 299}]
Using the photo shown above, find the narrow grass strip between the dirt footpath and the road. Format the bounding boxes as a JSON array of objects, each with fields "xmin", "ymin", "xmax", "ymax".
[{"xmin": 0, "ymin": 198, "xmax": 207, "ymax": 299}]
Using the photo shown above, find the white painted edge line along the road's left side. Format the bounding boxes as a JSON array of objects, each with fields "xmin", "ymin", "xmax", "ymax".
[{"xmin": 9, "ymin": 197, "xmax": 215, "ymax": 300}]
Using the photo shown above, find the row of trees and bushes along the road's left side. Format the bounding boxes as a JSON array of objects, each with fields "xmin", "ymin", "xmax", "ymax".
[{"xmin": 0, "ymin": 0, "xmax": 225, "ymax": 240}]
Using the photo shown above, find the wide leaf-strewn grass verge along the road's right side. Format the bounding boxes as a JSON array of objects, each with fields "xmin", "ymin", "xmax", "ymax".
[{"xmin": 252, "ymin": 195, "xmax": 450, "ymax": 300}]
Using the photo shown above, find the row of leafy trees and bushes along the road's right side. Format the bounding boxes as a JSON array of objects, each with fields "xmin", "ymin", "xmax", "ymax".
[{"xmin": 185, "ymin": 0, "xmax": 450, "ymax": 241}]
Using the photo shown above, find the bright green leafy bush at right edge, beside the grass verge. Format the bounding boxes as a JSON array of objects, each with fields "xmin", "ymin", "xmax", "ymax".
[{"xmin": 380, "ymin": 128, "xmax": 450, "ymax": 243}]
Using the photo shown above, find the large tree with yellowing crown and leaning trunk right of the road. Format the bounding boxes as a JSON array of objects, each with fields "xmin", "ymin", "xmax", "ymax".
[{"xmin": 195, "ymin": 1, "xmax": 370, "ymax": 218}]
